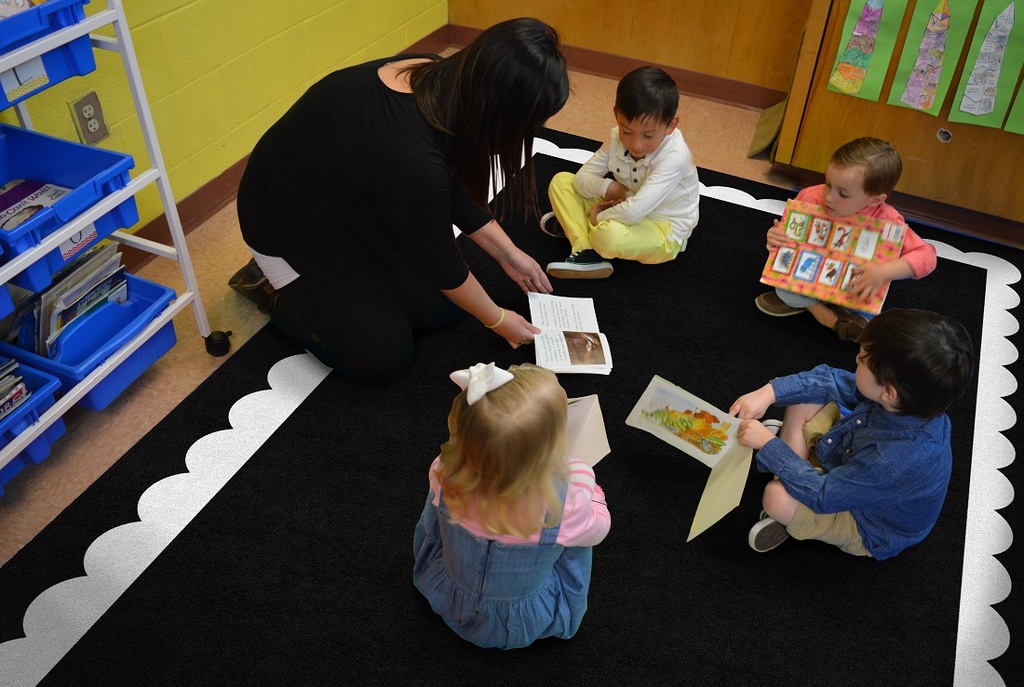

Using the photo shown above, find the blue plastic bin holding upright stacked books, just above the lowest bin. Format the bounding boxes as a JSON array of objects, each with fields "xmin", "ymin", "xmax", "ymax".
[{"xmin": 0, "ymin": 274, "xmax": 177, "ymax": 411}]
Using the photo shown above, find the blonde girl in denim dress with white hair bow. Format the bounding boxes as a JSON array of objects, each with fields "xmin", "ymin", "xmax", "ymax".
[{"xmin": 413, "ymin": 363, "xmax": 611, "ymax": 649}]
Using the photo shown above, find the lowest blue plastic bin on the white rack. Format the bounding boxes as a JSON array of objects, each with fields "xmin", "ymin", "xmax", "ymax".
[{"xmin": 0, "ymin": 363, "xmax": 65, "ymax": 495}]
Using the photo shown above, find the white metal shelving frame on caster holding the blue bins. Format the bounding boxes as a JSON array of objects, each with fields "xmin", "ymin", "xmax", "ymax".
[{"xmin": 0, "ymin": 0, "xmax": 227, "ymax": 468}]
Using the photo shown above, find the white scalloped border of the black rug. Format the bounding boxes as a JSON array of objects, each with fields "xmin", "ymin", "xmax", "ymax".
[{"xmin": 0, "ymin": 138, "xmax": 1021, "ymax": 687}]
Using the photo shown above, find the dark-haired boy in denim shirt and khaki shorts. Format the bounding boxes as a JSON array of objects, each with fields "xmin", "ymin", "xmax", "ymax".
[{"xmin": 729, "ymin": 310, "xmax": 975, "ymax": 560}]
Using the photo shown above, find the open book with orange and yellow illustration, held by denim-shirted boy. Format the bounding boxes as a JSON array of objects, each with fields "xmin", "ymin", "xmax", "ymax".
[{"xmin": 626, "ymin": 375, "xmax": 754, "ymax": 542}]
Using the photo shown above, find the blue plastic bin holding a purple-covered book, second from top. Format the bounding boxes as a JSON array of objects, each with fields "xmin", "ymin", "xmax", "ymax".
[{"xmin": 0, "ymin": 124, "xmax": 138, "ymax": 292}]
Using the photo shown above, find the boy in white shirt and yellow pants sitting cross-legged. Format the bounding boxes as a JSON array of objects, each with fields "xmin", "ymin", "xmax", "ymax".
[{"xmin": 541, "ymin": 67, "xmax": 700, "ymax": 280}]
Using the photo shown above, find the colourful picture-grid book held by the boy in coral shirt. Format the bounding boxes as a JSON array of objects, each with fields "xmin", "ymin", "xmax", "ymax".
[{"xmin": 761, "ymin": 201, "xmax": 906, "ymax": 314}]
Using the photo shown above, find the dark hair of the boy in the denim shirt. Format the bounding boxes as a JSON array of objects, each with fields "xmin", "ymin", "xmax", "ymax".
[{"xmin": 857, "ymin": 310, "xmax": 974, "ymax": 419}]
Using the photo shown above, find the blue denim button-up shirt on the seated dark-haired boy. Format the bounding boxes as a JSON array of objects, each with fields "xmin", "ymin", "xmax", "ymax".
[{"xmin": 757, "ymin": 364, "xmax": 952, "ymax": 560}]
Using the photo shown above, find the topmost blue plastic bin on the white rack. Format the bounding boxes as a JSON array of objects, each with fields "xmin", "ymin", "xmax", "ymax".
[{"xmin": 0, "ymin": 0, "xmax": 96, "ymax": 110}]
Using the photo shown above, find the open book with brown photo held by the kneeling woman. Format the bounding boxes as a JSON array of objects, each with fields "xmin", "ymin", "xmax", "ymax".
[{"xmin": 529, "ymin": 293, "xmax": 611, "ymax": 375}]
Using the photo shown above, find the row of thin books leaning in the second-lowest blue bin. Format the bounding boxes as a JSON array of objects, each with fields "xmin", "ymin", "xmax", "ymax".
[{"xmin": 0, "ymin": 243, "xmax": 128, "ymax": 357}]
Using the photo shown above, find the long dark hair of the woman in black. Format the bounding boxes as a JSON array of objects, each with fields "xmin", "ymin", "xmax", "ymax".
[{"xmin": 410, "ymin": 18, "xmax": 569, "ymax": 214}]
